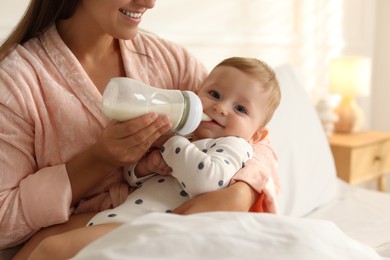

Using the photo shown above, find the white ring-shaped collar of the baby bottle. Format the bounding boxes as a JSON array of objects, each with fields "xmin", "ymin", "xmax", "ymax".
[{"xmin": 176, "ymin": 91, "xmax": 203, "ymax": 135}]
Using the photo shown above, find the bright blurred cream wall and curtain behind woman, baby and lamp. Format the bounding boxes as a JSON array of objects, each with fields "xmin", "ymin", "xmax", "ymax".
[{"xmin": 0, "ymin": 0, "xmax": 390, "ymax": 131}]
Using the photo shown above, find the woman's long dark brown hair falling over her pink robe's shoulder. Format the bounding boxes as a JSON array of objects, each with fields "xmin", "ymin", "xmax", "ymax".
[{"xmin": 0, "ymin": 0, "xmax": 79, "ymax": 61}]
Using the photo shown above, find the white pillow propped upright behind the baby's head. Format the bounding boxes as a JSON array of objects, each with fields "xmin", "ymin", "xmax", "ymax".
[{"xmin": 269, "ymin": 65, "xmax": 337, "ymax": 216}]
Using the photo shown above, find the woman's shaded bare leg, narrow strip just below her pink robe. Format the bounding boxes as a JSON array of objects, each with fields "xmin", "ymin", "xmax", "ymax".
[{"xmin": 13, "ymin": 213, "xmax": 95, "ymax": 260}]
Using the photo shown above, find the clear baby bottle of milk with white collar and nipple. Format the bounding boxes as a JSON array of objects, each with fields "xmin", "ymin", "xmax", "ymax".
[{"xmin": 102, "ymin": 77, "xmax": 210, "ymax": 135}]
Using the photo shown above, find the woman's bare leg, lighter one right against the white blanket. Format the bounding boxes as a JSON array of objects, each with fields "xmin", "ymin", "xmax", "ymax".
[{"xmin": 29, "ymin": 223, "xmax": 121, "ymax": 260}]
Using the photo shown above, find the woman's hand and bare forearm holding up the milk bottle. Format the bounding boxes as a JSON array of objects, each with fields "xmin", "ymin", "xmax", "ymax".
[{"xmin": 66, "ymin": 113, "xmax": 172, "ymax": 203}]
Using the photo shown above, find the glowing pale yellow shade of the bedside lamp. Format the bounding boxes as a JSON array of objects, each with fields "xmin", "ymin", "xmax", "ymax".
[{"xmin": 329, "ymin": 56, "xmax": 371, "ymax": 97}]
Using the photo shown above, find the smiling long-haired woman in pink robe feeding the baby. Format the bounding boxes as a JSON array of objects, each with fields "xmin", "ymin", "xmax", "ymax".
[{"xmin": 0, "ymin": 0, "xmax": 277, "ymax": 256}]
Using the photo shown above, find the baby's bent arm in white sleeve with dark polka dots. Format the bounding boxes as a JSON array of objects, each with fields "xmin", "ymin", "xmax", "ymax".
[{"xmin": 162, "ymin": 136, "xmax": 252, "ymax": 197}]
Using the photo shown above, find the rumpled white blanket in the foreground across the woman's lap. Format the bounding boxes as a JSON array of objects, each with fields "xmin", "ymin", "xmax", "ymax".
[{"xmin": 74, "ymin": 212, "xmax": 382, "ymax": 260}]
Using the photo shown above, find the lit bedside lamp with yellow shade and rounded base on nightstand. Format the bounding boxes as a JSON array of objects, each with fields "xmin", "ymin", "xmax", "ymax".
[{"xmin": 330, "ymin": 56, "xmax": 371, "ymax": 133}]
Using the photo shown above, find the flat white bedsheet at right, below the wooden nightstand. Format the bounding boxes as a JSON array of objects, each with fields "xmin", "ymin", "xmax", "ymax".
[{"xmin": 306, "ymin": 181, "xmax": 390, "ymax": 258}]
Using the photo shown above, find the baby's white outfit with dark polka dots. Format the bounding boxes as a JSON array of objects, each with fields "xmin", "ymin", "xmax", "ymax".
[{"xmin": 89, "ymin": 136, "xmax": 253, "ymax": 225}]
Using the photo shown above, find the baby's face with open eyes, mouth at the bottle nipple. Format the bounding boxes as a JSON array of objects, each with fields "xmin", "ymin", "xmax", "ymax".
[{"xmin": 194, "ymin": 66, "xmax": 269, "ymax": 140}]
